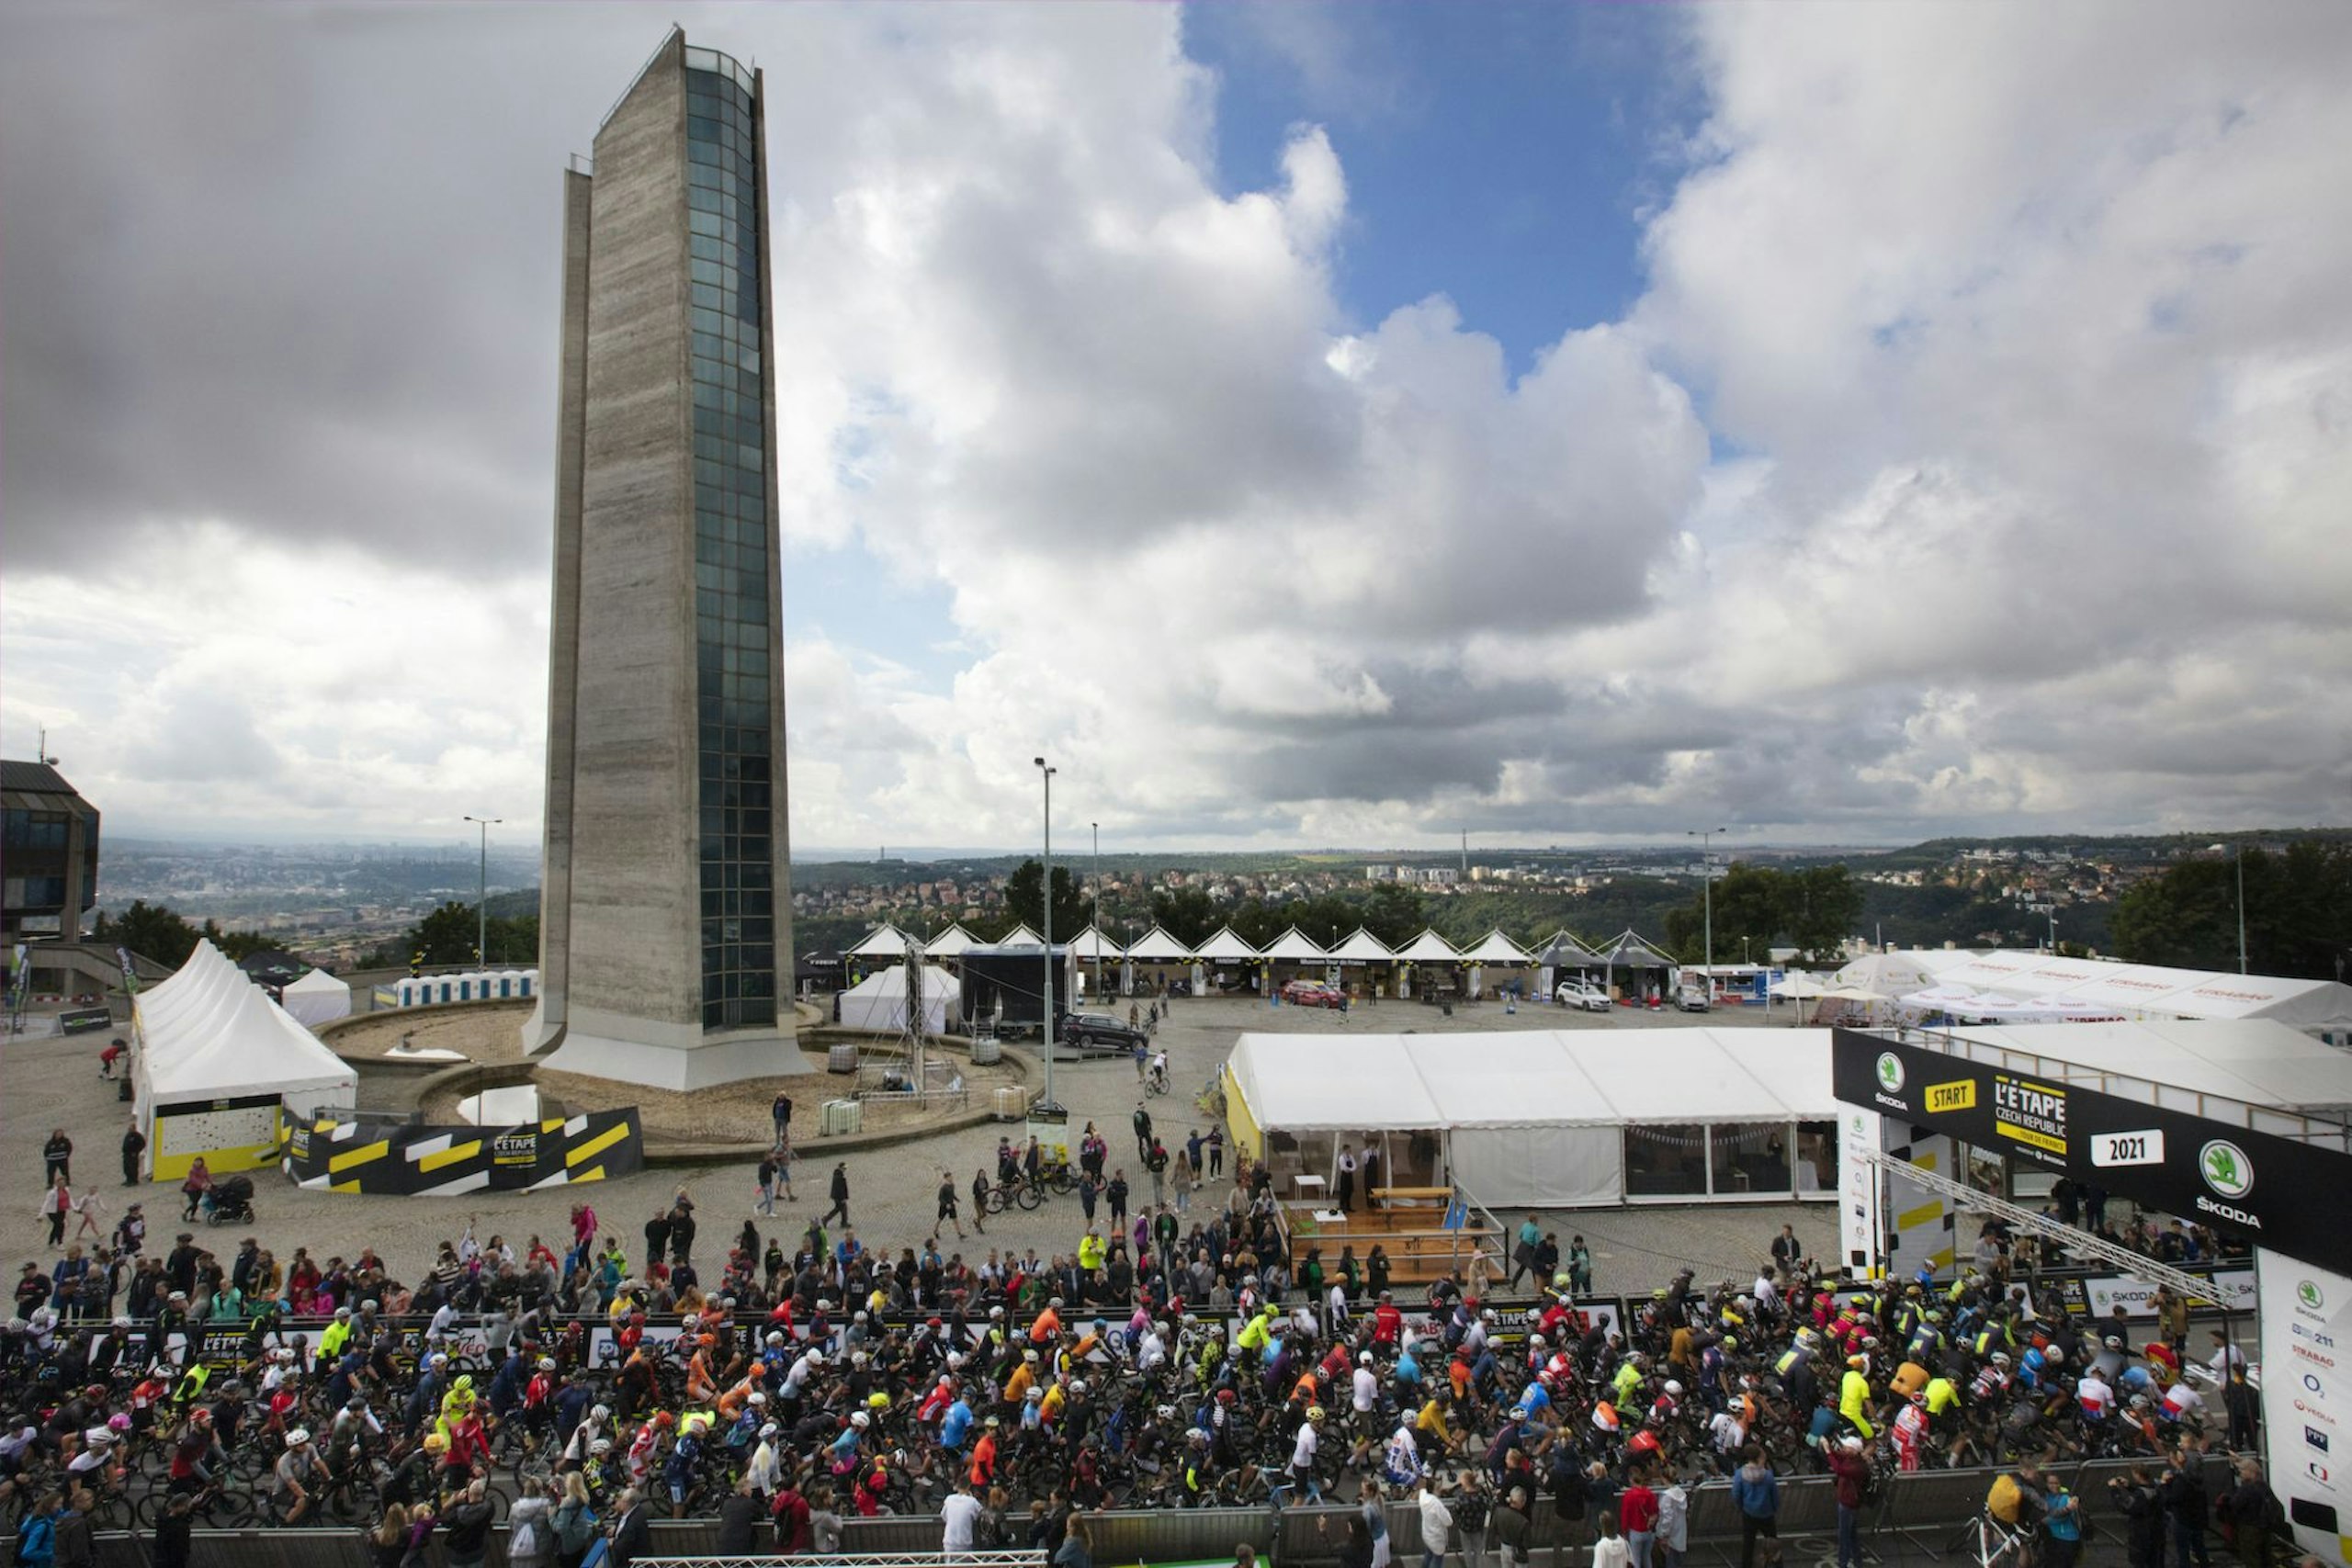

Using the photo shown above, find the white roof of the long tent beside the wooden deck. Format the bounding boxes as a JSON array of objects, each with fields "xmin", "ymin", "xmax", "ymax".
[{"xmin": 1230, "ymin": 1030, "xmax": 1837, "ymax": 1134}]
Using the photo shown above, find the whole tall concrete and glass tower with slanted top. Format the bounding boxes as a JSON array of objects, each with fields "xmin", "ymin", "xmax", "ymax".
[{"xmin": 525, "ymin": 28, "xmax": 809, "ymax": 1089}]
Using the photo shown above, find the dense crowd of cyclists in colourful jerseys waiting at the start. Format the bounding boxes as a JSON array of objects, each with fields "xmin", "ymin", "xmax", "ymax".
[{"xmin": 0, "ymin": 1133, "xmax": 2256, "ymax": 1568}]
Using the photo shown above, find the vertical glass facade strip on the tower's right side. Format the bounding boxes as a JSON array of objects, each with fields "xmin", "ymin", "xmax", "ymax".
[{"xmin": 684, "ymin": 50, "xmax": 778, "ymax": 1030}]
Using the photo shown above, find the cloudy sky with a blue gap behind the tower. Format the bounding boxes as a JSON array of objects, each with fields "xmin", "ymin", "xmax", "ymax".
[{"xmin": 0, "ymin": 0, "xmax": 2352, "ymax": 849}]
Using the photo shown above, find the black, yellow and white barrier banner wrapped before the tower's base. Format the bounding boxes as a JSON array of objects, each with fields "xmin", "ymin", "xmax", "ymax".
[{"xmin": 287, "ymin": 1105, "xmax": 644, "ymax": 1197}]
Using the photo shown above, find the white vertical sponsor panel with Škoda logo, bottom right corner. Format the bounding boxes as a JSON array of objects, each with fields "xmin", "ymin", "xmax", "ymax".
[{"xmin": 2253, "ymin": 1248, "xmax": 2352, "ymax": 1563}]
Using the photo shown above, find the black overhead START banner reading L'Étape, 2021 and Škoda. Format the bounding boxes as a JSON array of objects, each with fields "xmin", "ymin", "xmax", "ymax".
[{"xmin": 1830, "ymin": 1030, "xmax": 2352, "ymax": 1272}]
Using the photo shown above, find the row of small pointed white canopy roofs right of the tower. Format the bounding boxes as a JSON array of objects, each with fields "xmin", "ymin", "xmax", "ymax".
[{"xmin": 849, "ymin": 924, "xmax": 1675, "ymax": 968}]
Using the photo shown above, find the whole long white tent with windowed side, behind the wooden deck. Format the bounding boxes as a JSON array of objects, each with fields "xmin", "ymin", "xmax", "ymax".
[{"xmin": 1226, "ymin": 1030, "xmax": 1837, "ymax": 1208}]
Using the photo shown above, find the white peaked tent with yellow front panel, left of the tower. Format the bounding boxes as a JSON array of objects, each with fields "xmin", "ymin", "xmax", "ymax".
[{"xmin": 131, "ymin": 942, "xmax": 360, "ymax": 1180}]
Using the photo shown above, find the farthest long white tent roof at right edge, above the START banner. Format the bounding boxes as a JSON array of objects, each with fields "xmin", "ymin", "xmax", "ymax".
[{"xmin": 1837, "ymin": 947, "xmax": 2352, "ymax": 1043}]
